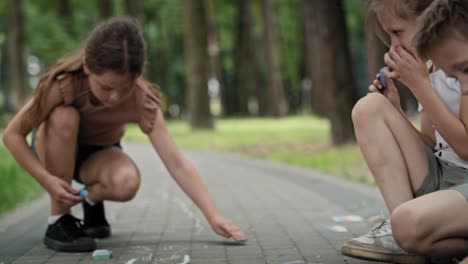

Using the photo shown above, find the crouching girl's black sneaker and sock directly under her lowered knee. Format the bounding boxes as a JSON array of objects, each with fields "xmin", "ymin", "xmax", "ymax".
[{"xmin": 82, "ymin": 201, "xmax": 111, "ymax": 238}]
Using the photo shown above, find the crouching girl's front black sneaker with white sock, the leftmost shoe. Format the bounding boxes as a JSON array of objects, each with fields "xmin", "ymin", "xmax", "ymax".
[{"xmin": 44, "ymin": 214, "xmax": 96, "ymax": 252}]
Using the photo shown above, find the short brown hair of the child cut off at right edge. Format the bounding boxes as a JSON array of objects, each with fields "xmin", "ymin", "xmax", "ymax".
[{"xmin": 414, "ymin": 0, "xmax": 468, "ymax": 59}]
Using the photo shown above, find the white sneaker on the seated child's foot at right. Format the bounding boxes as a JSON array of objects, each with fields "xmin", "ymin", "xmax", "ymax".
[{"xmin": 341, "ymin": 218, "xmax": 428, "ymax": 264}]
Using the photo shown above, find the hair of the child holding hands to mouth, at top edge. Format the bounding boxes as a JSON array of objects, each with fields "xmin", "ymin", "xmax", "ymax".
[{"xmin": 366, "ymin": 0, "xmax": 433, "ymax": 46}]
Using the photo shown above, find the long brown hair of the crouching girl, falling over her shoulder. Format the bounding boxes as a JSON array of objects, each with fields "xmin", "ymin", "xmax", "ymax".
[{"xmin": 26, "ymin": 18, "xmax": 159, "ymax": 127}]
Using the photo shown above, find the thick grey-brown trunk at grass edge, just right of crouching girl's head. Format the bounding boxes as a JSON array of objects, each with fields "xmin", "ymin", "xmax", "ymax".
[{"xmin": 184, "ymin": 0, "xmax": 213, "ymax": 129}]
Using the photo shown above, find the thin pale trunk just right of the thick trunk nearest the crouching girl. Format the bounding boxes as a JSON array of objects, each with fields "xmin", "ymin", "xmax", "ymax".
[{"xmin": 204, "ymin": 0, "xmax": 226, "ymax": 116}]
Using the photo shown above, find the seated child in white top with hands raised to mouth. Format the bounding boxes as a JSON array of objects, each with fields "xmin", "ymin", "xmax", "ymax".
[{"xmin": 342, "ymin": 0, "xmax": 468, "ymax": 263}]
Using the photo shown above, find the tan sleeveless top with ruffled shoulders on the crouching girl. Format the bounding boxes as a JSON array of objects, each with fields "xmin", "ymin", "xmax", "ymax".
[{"xmin": 58, "ymin": 73, "xmax": 159, "ymax": 146}]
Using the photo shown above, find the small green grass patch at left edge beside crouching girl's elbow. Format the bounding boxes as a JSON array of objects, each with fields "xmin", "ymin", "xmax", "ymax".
[{"xmin": 0, "ymin": 145, "xmax": 42, "ymax": 214}]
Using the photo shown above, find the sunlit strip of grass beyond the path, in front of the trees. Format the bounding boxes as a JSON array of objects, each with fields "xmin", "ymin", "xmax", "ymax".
[{"xmin": 125, "ymin": 116, "xmax": 373, "ymax": 183}]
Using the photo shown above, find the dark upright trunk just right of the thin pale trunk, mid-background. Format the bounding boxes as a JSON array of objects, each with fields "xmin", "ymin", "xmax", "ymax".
[{"xmin": 227, "ymin": 0, "xmax": 254, "ymax": 115}]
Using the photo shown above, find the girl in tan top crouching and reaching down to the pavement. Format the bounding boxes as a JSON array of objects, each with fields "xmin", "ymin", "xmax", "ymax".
[{"xmin": 3, "ymin": 18, "xmax": 247, "ymax": 252}]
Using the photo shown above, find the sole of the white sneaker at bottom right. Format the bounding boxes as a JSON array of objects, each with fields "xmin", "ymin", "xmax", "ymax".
[{"xmin": 341, "ymin": 243, "xmax": 429, "ymax": 264}]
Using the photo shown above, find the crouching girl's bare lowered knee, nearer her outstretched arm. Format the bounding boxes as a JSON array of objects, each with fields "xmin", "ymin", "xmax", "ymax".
[{"xmin": 80, "ymin": 148, "xmax": 140, "ymax": 201}]
